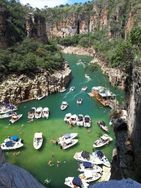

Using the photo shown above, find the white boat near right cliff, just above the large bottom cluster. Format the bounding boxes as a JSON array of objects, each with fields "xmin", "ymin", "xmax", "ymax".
[{"xmin": 93, "ymin": 134, "xmax": 113, "ymax": 148}]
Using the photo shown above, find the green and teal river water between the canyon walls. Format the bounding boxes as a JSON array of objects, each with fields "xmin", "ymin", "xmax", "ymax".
[{"xmin": 0, "ymin": 55, "xmax": 124, "ymax": 188}]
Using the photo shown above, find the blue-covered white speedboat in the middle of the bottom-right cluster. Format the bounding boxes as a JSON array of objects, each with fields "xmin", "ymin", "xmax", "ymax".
[{"xmin": 78, "ymin": 162, "xmax": 103, "ymax": 173}]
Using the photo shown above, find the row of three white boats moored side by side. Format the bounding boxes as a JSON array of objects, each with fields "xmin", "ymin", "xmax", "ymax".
[{"xmin": 28, "ymin": 107, "xmax": 49, "ymax": 120}]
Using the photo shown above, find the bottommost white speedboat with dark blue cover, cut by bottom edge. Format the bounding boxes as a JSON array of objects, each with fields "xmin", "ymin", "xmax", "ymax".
[{"xmin": 64, "ymin": 177, "xmax": 89, "ymax": 188}]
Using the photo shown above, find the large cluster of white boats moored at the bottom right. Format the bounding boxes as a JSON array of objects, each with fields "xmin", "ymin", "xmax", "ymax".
[{"xmin": 64, "ymin": 150, "xmax": 111, "ymax": 188}]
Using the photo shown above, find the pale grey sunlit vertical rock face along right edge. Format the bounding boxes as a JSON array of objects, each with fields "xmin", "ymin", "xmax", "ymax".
[{"xmin": 128, "ymin": 67, "xmax": 141, "ymax": 154}]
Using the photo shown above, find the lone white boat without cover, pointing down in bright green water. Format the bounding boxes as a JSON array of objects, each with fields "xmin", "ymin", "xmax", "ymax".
[{"xmin": 33, "ymin": 132, "xmax": 43, "ymax": 149}]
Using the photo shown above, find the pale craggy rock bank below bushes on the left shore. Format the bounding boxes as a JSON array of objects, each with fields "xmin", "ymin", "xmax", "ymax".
[{"xmin": 0, "ymin": 63, "xmax": 71, "ymax": 103}]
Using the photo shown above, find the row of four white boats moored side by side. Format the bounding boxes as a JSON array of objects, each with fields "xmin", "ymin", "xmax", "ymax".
[{"xmin": 64, "ymin": 113, "xmax": 92, "ymax": 128}]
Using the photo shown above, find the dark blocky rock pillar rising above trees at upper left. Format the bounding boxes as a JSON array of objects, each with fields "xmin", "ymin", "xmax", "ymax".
[{"xmin": 26, "ymin": 13, "xmax": 48, "ymax": 42}]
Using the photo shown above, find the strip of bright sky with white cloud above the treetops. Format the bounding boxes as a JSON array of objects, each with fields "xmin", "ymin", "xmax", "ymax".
[{"xmin": 20, "ymin": 0, "xmax": 88, "ymax": 9}]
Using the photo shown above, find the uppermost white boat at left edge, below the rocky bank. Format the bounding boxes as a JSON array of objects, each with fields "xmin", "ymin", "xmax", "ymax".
[{"xmin": 0, "ymin": 103, "xmax": 17, "ymax": 114}]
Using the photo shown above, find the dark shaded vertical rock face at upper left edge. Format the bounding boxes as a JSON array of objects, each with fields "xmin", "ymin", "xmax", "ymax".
[{"xmin": 0, "ymin": 5, "xmax": 7, "ymax": 48}]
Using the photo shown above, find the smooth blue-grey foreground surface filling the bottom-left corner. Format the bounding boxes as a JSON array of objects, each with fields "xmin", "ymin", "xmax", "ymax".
[{"xmin": 0, "ymin": 149, "xmax": 44, "ymax": 188}]
